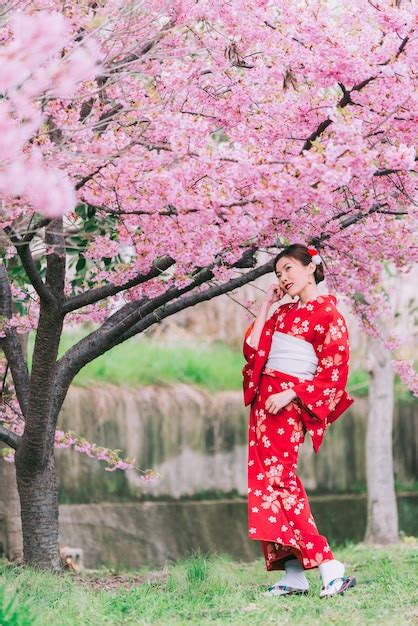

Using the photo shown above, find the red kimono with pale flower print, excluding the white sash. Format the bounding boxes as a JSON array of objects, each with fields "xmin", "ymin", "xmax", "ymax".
[{"xmin": 243, "ymin": 295, "xmax": 354, "ymax": 570}]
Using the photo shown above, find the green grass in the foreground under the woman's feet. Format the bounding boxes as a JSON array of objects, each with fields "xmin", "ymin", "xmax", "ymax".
[{"xmin": 0, "ymin": 538, "xmax": 418, "ymax": 626}]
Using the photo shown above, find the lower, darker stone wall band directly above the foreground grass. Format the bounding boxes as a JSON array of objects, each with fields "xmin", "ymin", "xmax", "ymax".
[{"xmin": 56, "ymin": 494, "xmax": 418, "ymax": 568}]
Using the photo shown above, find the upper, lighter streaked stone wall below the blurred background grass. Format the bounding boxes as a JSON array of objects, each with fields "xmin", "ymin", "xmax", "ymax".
[{"xmin": 57, "ymin": 384, "xmax": 418, "ymax": 503}]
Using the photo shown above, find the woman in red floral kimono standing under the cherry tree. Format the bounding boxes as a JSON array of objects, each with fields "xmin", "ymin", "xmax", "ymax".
[{"xmin": 243, "ymin": 244, "xmax": 356, "ymax": 597}]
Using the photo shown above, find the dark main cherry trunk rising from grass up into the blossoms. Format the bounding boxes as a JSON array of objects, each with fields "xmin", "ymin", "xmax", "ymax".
[{"xmin": 13, "ymin": 219, "xmax": 65, "ymax": 570}]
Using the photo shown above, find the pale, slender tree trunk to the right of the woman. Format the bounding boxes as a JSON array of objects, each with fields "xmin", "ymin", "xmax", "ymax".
[{"xmin": 365, "ymin": 338, "xmax": 399, "ymax": 544}]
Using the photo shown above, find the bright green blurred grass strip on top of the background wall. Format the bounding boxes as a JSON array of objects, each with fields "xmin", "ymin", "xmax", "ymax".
[{"xmin": 28, "ymin": 331, "xmax": 412, "ymax": 399}]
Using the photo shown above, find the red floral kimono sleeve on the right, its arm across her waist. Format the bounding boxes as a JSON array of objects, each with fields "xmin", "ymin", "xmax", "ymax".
[{"xmin": 293, "ymin": 308, "xmax": 350, "ymax": 421}]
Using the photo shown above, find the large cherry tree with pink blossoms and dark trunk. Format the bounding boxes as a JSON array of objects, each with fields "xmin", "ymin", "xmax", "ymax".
[{"xmin": 0, "ymin": 0, "xmax": 417, "ymax": 568}]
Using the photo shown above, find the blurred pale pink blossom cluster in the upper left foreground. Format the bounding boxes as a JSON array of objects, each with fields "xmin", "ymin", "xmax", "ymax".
[{"xmin": 0, "ymin": 11, "xmax": 99, "ymax": 217}]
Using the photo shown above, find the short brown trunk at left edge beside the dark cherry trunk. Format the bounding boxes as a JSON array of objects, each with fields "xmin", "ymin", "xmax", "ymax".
[{"xmin": 0, "ymin": 457, "xmax": 23, "ymax": 564}]
